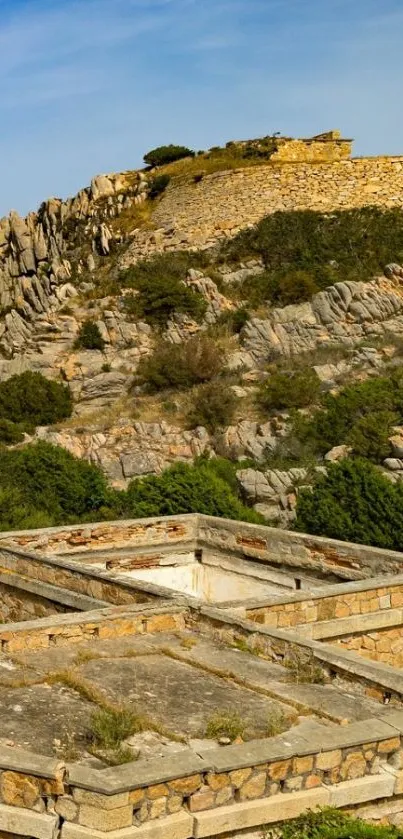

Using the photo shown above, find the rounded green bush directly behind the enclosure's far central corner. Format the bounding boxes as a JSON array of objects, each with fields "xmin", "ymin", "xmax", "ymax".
[{"xmin": 120, "ymin": 463, "xmax": 264, "ymax": 524}]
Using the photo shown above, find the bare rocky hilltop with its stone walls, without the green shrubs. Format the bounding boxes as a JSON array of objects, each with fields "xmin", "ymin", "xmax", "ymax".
[{"xmin": 0, "ymin": 132, "xmax": 403, "ymax": 521}]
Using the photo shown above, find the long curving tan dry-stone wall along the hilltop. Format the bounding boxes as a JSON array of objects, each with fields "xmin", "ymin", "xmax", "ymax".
[{"xmin": 153, "ymin": 157, "xmax": 403, "ymax": 244}]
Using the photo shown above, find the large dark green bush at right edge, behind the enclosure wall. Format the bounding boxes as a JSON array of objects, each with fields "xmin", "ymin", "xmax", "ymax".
[{"xmin": 295, "ymin": 459, "xmax": 403, "ymax": 551}]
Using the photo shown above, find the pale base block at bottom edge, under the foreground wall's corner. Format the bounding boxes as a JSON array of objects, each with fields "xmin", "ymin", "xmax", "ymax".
[{"xmin": 61, "ymin": 812, "xmax": 193, "ymax": 839}]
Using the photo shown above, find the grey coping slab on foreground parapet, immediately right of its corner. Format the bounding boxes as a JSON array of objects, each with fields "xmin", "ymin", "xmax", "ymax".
[{"xmin": 68, "ymin": 749, "xmax": 213, "ymax": 795}]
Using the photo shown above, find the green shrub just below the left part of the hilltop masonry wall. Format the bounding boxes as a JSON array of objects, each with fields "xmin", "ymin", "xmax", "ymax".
[{"xmin": 120, "ymin": 254, "xmax": 207, "ymax": 326}]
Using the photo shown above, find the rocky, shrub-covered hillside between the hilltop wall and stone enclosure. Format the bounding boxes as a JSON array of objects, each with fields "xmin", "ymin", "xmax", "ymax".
[{"xmin": 0, "ymin": 144, "xmax": 403, "ymax": 549}]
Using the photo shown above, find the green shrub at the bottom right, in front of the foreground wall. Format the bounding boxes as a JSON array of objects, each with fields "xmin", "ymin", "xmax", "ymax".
[{"xmin": 263, "ymin": 807, "xmax": 401, "ymax": 839}]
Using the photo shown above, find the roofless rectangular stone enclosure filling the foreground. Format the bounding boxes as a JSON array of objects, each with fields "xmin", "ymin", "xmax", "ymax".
[{"xmin": 0, "ymin": 515, "xmax": 403, "ymax": 839}]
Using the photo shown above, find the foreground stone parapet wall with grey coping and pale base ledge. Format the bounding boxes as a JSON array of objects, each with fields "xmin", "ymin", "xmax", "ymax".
[{"xmin": 0, "ymin": 712, "xmax": 403, "ymax": 839}]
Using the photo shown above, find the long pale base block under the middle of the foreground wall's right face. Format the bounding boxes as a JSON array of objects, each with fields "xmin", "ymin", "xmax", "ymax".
[{"xmin": 193, "ymin": 787, "xmax": 330, "ymax": 839}]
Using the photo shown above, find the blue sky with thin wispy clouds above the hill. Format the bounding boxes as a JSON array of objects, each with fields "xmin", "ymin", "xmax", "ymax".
[{"xmin": 0, "ymin": 0, "xmax": 403, "ymax": 216}]
